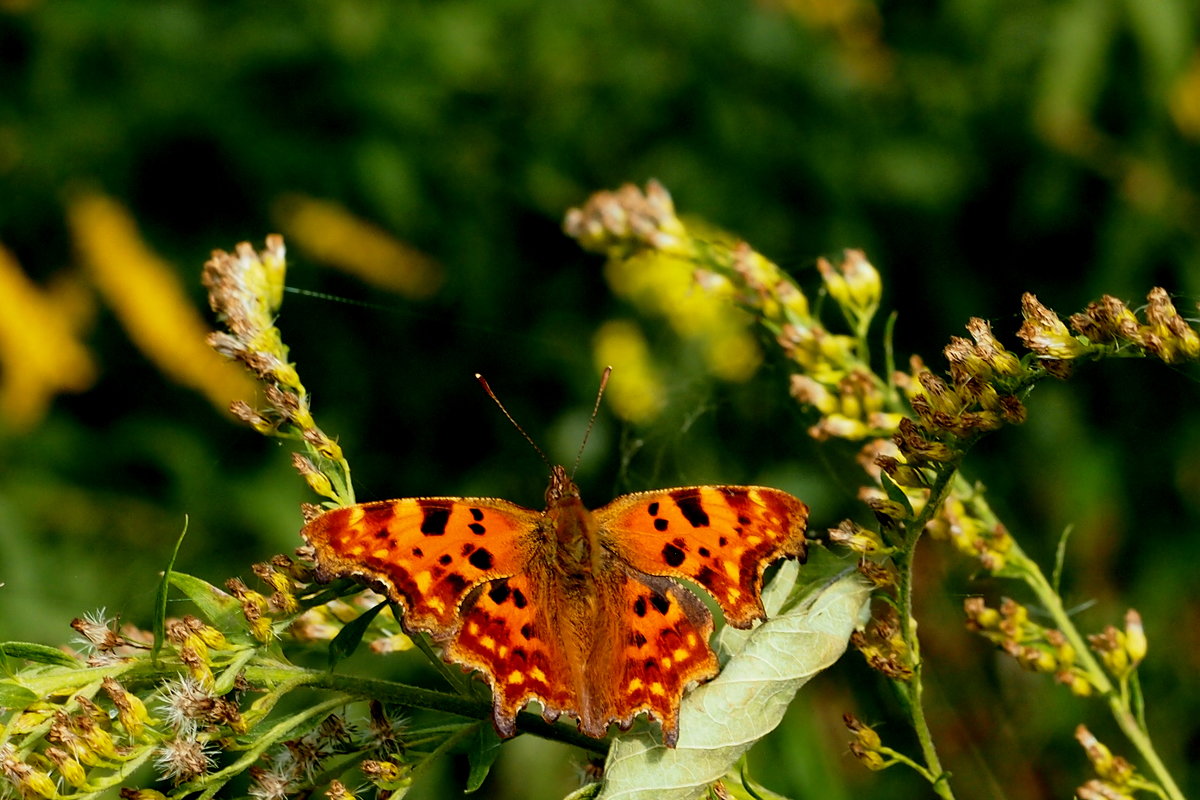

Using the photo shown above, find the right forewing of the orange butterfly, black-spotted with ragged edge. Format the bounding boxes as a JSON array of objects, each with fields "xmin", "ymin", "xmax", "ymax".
[{"xmin": 593, "ymin": 486, "xmax": 809, "ymax": 627}]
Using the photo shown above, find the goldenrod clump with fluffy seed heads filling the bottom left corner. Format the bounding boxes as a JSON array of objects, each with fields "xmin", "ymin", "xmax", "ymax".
[{"xmin": 0, "ymin": 555, "xmax": 422, "ymax": 800}]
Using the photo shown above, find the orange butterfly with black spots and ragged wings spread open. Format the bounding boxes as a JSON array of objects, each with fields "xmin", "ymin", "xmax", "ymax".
[{"xmin": 301, "ymin": 467, "xmax": 808, "ymax": 746}]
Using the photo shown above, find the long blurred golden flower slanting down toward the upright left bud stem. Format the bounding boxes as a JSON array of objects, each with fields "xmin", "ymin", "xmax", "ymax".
[{"xmin": 67, "ymin": 193, "xmax": 254, "ymax": 410}]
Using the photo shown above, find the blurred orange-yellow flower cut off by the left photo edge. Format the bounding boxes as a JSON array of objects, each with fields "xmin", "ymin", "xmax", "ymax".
[{"xmin": 0, "ymin": 247, "xmax": 96, "ymax": 429}]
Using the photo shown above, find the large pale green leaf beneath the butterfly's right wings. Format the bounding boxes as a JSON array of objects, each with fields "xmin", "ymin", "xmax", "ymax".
[{"xmin": 599, "ymin": 564, "xmax": 870, "ymax": 800}]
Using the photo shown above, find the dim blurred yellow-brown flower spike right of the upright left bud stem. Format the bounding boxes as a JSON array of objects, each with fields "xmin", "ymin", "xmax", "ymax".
[{"xmin": 276, "ymin": 194, "xmax": 442, "ymax": 300}]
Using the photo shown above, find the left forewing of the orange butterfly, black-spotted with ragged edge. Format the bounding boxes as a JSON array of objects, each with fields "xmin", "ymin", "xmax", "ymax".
[{"xmin": 301, "ymin": 498, "xmax": 541, "ymax": 638}]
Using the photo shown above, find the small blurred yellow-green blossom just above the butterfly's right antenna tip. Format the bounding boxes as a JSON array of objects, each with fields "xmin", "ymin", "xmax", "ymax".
[{"xmin": 593, "ymin": 319, "xmax": 665, "ymax": 423}]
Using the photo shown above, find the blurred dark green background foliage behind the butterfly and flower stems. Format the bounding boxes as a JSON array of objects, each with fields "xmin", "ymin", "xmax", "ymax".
[{"xmin": 0, "ymin": 0, "xmax": 1200, "ymax": 799}]
